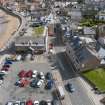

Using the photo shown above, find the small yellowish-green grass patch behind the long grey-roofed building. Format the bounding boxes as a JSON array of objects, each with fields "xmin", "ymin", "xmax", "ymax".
[{"xmin": 33, "ymin": 26, "xmax": 44, "ymax": 37}]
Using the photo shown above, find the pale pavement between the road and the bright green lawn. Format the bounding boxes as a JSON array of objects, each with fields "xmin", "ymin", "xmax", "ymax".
[{"xmin": 78, "ymin": 77, "xmax": 103, "ymax": 105}]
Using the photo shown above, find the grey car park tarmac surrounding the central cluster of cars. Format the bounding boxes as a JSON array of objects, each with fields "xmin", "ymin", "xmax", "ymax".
[{"xmin": 0, "ymin": 55, "xmax": 54, "ymax": 105}]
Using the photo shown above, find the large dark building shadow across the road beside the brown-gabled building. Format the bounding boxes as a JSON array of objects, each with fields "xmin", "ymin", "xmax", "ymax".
[{"xmin": 56, "ymin": 52, "xmax": 78, "ymax": 80}]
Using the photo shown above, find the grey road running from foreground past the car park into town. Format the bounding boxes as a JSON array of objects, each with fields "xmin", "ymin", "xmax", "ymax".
[{"xmin": 52, "ymin": 21, "xmax": 94, "ymax": 105}]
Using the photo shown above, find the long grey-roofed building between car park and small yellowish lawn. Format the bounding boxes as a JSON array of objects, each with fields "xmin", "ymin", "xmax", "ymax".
[{"xmin": 14, "ymin": 36, "xmax": 46, "ymax": 53}]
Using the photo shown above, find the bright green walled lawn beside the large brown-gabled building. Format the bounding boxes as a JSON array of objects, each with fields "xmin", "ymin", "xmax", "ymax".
[{"xmin": 83, "ymin": 68, "xmax": 105, "ymax": 91}]
